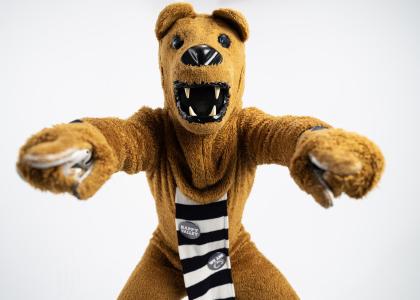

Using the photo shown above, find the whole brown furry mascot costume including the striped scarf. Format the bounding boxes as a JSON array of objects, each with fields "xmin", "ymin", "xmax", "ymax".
[{"xmin": 17, "ymin": 3, "xmax": 384, "ymax": 300}]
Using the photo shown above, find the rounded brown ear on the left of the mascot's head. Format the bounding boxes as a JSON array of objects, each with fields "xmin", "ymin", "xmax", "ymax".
[{"xmin": 155, "ymin": 3, "xmax": 196, "ymax": 40}]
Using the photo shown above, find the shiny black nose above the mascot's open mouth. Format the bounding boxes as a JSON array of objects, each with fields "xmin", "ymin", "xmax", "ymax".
[{"xmin": 181, "ymin": 45, "xmax": 223, "ymax": 66}]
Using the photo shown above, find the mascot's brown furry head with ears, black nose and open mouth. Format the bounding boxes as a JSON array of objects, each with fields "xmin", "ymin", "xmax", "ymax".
[{"xmin": 155, "ymin": 3, "xmax": 248, "ymax": 134}]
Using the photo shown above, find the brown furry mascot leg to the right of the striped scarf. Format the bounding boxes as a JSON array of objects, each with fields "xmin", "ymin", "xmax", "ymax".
[{"xmin": 232, "ymin": 242, "xmax": 299, "ymax": 300}]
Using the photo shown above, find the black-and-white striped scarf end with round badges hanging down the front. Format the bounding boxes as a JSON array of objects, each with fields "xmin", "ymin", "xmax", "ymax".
[{"xmin": 175, "ymin": 188, "xmax": 235, "ymax": 300}]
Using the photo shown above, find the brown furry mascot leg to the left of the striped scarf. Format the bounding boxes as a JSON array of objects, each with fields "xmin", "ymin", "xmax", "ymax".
[{"xmin": 118, "ymin": 244, "xmax": 186, "ymax": 300}]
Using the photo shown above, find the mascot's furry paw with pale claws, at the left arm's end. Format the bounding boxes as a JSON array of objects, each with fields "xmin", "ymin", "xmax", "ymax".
[{"xmin": 17, "ymin": 123, "xmax": 116, "ymax": 199}]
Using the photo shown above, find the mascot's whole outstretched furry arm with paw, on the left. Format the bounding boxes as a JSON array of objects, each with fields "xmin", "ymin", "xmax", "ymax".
[{"xmin": 17, "ymin": 108, "xmax": 160, "ymax": 199}]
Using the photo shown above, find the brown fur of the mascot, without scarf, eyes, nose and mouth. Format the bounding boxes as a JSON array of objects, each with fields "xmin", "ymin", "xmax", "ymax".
[{"xmin": 18, "ymin": 4, "xmax": 384, "ymax": 299}]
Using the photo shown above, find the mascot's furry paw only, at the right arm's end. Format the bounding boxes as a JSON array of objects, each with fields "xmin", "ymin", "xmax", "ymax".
[{"xmin": 290, "ymin": 129, "xmax": 384, "ymax": 208}]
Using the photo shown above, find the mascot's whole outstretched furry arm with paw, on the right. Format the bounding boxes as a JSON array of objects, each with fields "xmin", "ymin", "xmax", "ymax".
[{"xmin": 240, "ymin": 108, "xmax": 384, "ymax": 208}]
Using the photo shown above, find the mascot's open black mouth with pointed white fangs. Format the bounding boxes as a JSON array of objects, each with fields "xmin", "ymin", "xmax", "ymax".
[{"xmin": 174, "ymin": 81, "xmax": 229, "ymax": 123}]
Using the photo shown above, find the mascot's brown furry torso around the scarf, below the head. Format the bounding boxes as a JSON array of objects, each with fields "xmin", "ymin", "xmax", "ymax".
[{"xmin": 147, "ymin": 109, "xmax": 256, "ymax": 266}]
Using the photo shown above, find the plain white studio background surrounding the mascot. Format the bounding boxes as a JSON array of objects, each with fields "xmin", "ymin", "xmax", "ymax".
[{"xmin": 0, "ymin": 0, "xmax": 420, "ymax": 300}]
